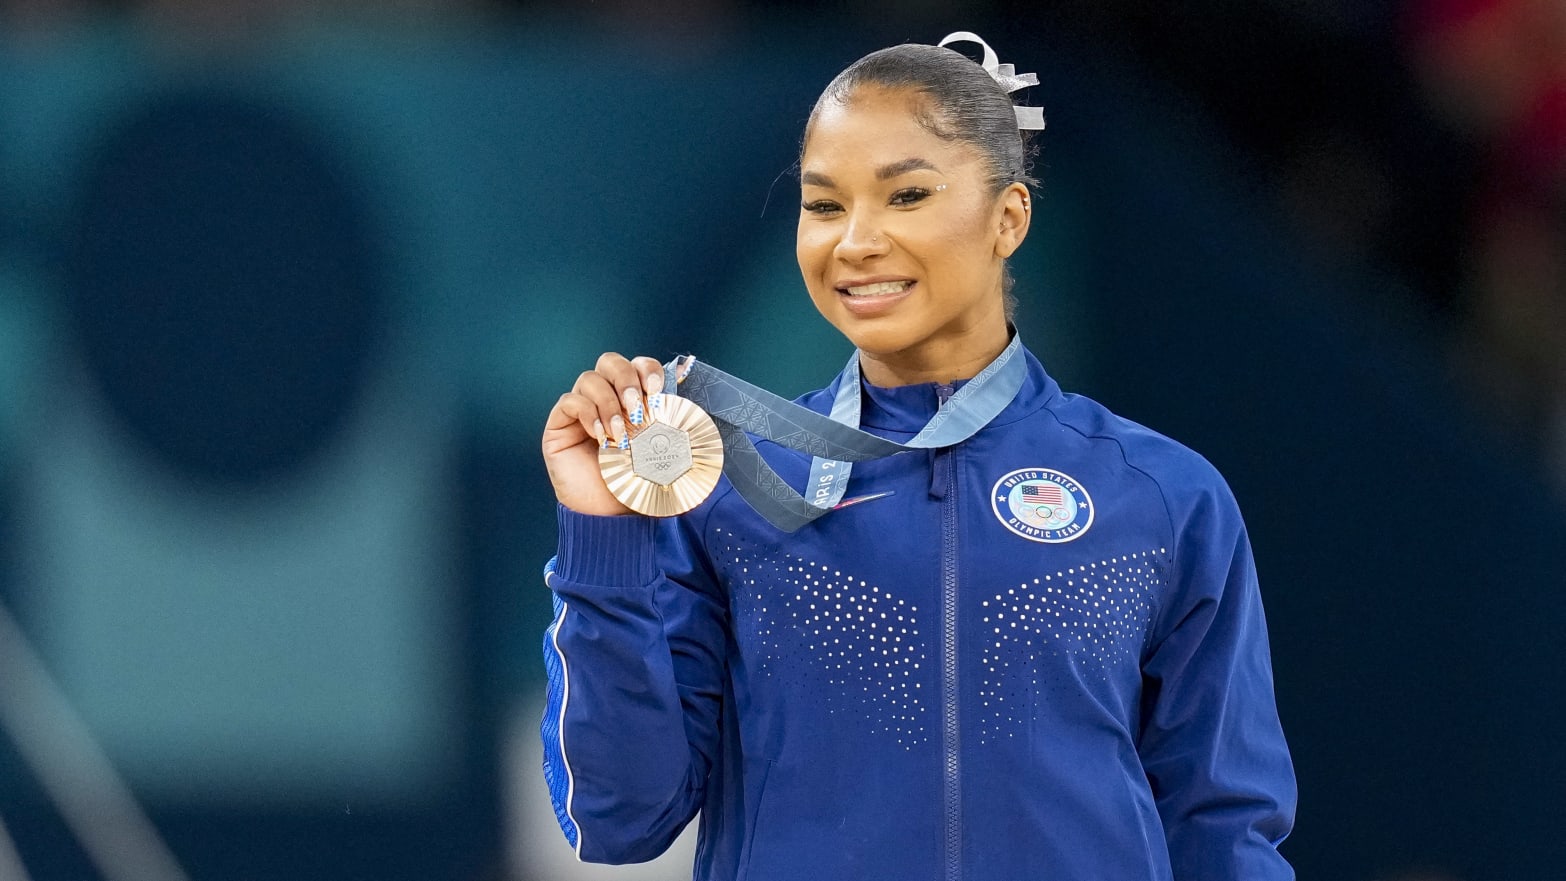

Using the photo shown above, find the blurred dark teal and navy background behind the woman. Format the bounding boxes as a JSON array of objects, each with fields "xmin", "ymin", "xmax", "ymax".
[{"xmin": 0, "ymin": 0, "xmax": 1566, "ymax": 881}]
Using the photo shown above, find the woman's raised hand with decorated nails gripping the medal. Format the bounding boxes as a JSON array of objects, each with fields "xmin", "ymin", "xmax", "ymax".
[{"xmin": 543, "ymin": 352, "xmax": 664, "ymax": 515}]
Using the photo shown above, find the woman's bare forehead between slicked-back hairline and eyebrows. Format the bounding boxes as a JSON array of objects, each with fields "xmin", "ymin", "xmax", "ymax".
[{"xmin": 800, "ymin": 86, "xmax": 979, "ymax": 174}]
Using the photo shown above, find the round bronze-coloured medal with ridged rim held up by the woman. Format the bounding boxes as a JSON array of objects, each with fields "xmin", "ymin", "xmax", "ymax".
[{"xmin": 598, "ymin": 394, "xmax": 723, "ymax": 516}]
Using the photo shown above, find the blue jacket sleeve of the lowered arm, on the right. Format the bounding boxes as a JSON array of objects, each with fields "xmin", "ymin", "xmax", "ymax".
[{"xmin": 1138, "ymin": 475, "xmax": 1297, "ymax": 881}]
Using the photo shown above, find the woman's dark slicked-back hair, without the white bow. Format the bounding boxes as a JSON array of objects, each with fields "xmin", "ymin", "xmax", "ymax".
[{"xmin": 805, "ymin": 42, "xmax": 1038, "ymax": 192}]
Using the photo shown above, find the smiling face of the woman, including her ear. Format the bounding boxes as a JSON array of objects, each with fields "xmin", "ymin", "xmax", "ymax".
[{"xmin": 796, "ymin": 86, "xmax": 1027, "ymax": 385}]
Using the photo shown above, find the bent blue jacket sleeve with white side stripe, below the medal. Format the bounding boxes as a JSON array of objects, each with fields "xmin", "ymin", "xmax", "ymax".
[{"xmin": 542, "ymin": 509, "xmax": 727, "ymax": 862}]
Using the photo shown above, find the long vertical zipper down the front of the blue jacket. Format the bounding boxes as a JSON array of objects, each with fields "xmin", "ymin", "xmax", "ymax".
[{"xmin": 930, "ymin": 385, "xmax": 963, "ymax": 881}]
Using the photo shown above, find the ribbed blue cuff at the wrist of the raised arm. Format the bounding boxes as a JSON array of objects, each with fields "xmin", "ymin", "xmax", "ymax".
[{"xmin": 554, "ymin": 505, "xmax": 658, "ymax": 587}]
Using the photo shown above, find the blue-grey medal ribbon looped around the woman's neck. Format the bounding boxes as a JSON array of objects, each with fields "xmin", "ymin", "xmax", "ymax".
[{"xmin": 664, "ymin": 335, "xmax": 1027, "ymax": 532}]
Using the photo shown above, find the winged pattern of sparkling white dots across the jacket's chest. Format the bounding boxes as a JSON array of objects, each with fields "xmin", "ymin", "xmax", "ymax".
[{"xmin": 714, "ymin": 529, "xmax": 1167, "ymax": 748}]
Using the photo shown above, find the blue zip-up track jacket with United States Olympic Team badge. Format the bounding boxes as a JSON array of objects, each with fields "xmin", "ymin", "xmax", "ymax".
[{"xmin": 543, "ymin": 348, "xmax": 1295, "ymax": 881}]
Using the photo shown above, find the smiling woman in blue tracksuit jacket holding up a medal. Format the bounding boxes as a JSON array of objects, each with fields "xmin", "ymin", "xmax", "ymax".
[{"xmin": 543, "ymin": 31, "xmax": 1295, "ymax": 881}]
